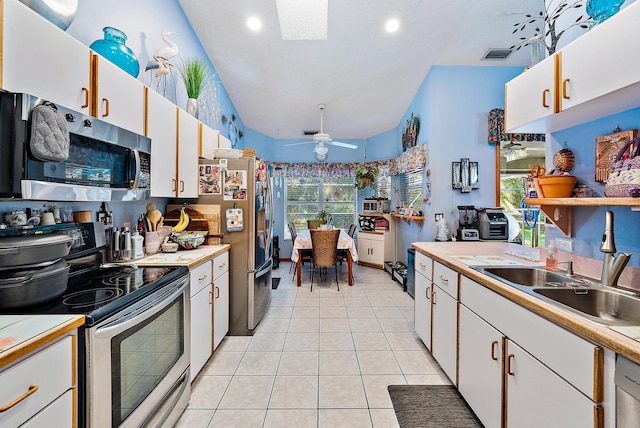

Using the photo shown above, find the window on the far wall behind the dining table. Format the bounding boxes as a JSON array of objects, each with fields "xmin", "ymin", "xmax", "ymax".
[{"xmin": 285, "ymin": 177, "xmax": 356, "ymax": 239}]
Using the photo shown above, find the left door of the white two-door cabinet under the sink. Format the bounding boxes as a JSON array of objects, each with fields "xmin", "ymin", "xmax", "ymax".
[{"xmin": 458, "ymin": 305, "xmax": 502, "ymax": 427}]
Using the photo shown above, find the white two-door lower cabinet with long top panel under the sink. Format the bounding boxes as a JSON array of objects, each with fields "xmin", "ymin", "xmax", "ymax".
[{"xmin": 460, "ymin": 276, "xmax": 612, "ymax": 428}]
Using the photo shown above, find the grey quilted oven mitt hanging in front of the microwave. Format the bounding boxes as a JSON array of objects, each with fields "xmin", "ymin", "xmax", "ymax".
[{"xmin": 30, "ymin": 101, "xmax": 69, "ymax": 162}]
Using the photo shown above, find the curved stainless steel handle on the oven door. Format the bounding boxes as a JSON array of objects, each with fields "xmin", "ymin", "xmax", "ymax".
[{"xmin": 95, "ymin": 277, "xmax": 189, "ymax": 339}]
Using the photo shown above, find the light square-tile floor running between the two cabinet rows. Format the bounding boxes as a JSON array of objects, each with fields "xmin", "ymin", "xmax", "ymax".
[{"xmin": 176, "ymin": 263, "xmax": 449, "ymax": 428}]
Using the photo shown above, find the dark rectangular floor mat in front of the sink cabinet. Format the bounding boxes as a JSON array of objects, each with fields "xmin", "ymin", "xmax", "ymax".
[{"xmin": 387, "ymin": 385, "xmax": 482, "ymax": 428}]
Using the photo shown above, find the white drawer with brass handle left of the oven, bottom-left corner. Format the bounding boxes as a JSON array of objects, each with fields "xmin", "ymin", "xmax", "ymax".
[{"xmin": 0, "ymin": 336, "xmax": 75, "ymax": 427}]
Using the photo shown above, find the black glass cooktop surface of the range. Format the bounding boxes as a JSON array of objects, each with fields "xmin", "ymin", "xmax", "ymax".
[{"xmin": 3, "ymin": 266, "xmax": 189, "ymax": 325}]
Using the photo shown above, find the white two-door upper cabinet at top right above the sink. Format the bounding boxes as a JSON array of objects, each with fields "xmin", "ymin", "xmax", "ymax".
[{"xmin": 505, "ymin": 2, "xmax": 640, "ymax": 133}]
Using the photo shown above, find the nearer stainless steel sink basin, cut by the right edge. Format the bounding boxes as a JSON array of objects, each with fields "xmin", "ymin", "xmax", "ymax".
[{"xmin": 533, "ymin": 287, "xmax": 640, "ymax": 325}]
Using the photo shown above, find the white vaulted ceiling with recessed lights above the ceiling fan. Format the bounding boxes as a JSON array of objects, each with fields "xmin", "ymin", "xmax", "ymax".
[{"xmin": 180, "ymin": 0, "xmax": 543, "ymax": 140}]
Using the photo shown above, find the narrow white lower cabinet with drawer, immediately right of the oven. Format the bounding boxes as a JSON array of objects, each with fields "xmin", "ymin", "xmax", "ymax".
[{"xmin": 189, "ymin": 260, "xmax": 213, "ymax": 381}]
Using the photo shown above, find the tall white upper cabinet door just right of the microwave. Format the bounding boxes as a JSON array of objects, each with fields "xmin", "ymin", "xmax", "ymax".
[{"xmin": 145, "ymin": 90, "xmax": 178, "ymax": 198}]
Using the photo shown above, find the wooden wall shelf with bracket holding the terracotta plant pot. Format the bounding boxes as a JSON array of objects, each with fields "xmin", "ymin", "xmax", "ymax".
[{"xmin": 524, "ymin": 198, "xmax": 640, "ymax": 237}]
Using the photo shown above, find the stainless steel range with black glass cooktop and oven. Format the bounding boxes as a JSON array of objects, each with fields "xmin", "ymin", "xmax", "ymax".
[{"xmin": 0, "ymin": 223, "xmax": 191, "ymax": 428}]
